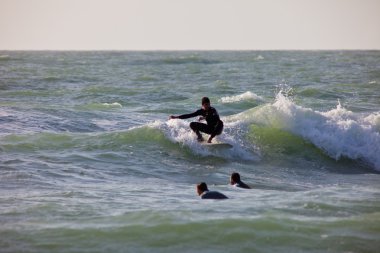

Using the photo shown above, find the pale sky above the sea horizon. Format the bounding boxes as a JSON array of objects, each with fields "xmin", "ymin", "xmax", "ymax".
[{"xmin": 0, "ymin": 0, "xmax": 380, "ymax": 50}]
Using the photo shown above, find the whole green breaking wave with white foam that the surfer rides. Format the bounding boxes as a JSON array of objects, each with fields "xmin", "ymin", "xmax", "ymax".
[{"xmin": 0, "ymin": 92, "xmax": 380, "ymax": 170}]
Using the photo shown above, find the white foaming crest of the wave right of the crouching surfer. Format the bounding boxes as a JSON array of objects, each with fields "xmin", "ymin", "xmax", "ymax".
[{"xmin": 229, "ymin": 92, "xmax": 380, "ymax": 170}]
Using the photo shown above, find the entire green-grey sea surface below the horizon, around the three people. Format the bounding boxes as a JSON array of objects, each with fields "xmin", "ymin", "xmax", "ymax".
[{"xmin": 0, "ymin": 51, "xmax": 380, "ymax": 253}]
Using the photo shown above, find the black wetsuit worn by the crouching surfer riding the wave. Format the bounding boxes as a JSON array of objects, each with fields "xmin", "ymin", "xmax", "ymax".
[{"xmin": 179, "ymin": 107, "xmax": 223, "ymax": 138}]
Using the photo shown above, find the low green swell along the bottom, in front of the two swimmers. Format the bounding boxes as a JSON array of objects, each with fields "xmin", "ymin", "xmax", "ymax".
[{"xmin": 0, "ymin": 211, "xmax": 379, "ymax": 252}]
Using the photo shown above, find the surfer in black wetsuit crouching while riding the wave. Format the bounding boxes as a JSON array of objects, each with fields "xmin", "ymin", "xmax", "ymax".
[{"xmin": 169, "ymin": 97, "xmax": 223, "ymax": 143}]
